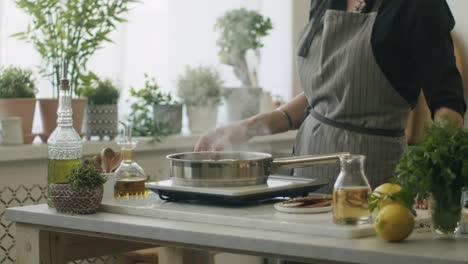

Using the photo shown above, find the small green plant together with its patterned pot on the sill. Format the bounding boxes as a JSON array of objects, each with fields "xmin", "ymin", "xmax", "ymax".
[{"xmin": 80, "ymin": 74, "xmax": 120, "ymax": 140}]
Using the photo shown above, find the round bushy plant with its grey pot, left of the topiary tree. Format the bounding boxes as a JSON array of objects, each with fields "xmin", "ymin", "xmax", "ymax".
[{"xmin": 177, "ymin": 66, "xmax": 223, "ymax": 133}]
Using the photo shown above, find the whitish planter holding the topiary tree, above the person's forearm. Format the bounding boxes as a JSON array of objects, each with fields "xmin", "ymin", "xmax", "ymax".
[{"xmin": 224, "ymin": 88, "xmax": 263, "ymax": 122}]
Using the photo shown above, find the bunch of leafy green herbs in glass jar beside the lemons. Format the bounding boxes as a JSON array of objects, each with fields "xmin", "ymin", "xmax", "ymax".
[{"xmin": 396, "ymin": 119, "xmax": 468, "ymax": 237}]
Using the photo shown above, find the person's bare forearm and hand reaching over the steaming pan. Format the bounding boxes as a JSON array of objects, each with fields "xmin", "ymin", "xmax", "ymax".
[{"xmin": 195, "ymin": 93, "xmax": 308, "ymax": 151}]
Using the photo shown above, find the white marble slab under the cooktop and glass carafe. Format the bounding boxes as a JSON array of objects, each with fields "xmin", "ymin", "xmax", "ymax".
[{"xmin": 101, "ymin": 193, "xmax": 375, "ymax": 238}]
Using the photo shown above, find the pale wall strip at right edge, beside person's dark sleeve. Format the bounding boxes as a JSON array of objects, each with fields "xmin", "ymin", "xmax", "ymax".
[{"xmin": 447, "ymin": 0, "xmax": 468, "ymax": 127}]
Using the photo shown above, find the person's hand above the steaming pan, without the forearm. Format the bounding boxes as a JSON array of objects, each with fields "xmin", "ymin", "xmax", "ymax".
[{"xmin": 195, "ymin": 121, "xmax": 252, "ymax": 151}]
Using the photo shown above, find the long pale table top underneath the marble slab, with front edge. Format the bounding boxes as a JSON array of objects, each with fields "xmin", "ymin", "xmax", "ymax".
[{"xmin": 6, "ymin": 197, "xmax": 468, "ymax": 264}]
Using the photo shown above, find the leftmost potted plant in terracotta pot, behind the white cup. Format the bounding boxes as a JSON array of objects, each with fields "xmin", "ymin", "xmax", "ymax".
[{"xmin": 0, "ymin": 66, "xmax": 36, "ymax": 144}]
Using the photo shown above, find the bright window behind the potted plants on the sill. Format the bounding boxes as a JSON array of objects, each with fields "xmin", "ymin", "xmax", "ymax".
[{"xmin": 0, "ymin": 0, "xmax": 294, "ymax": 130}]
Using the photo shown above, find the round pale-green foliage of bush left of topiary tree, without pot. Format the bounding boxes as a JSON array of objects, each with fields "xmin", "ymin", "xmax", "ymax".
[{"xmin": 177, "ymin": 66, "xmax": 223, "ymax": 105}]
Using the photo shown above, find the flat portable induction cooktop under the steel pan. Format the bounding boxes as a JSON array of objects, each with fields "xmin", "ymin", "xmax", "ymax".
[{"xmin": 146, "ymin": 175, "xmax": 328, "ymax": 205}]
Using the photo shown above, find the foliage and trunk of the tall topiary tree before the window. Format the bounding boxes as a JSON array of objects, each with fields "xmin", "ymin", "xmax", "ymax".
[{"xmin": 215, "ymin": 8, "xmax": 273, "ymax": 87}]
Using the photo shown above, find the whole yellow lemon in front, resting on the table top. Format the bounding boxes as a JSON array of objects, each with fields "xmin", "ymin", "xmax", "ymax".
[{"xmin": 374, "ymin": 204, "xmax": 414, "ymax": 242}]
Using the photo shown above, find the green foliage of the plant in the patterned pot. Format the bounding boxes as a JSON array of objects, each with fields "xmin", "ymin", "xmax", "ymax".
[{"xmin": 80, "ymin": 74, "xmax": 120, "ymax": 105}]
